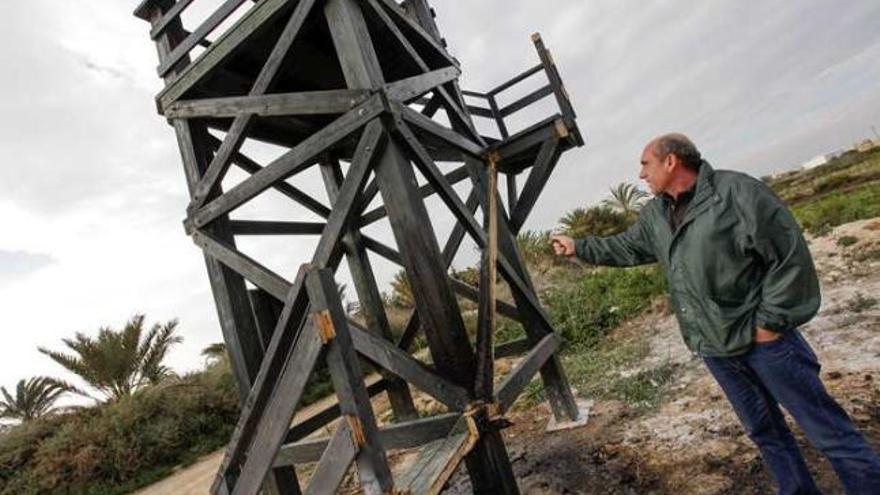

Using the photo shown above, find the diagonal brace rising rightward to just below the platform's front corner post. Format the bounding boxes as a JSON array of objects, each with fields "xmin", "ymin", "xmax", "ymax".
[{"xmin": 192, "ymin": 96, "xmax": 382, "ymax": 226}]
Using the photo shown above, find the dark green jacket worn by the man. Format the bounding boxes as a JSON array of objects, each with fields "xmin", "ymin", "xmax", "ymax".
[{"xmin": 575, "ymin": 162, "xmax": 820, "ymax": 356}]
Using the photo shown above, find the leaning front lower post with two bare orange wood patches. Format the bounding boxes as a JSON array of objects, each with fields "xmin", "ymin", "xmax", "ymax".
[{"xmin": 308, "ymin": 269, "xmax": 394, "ymax": 495}]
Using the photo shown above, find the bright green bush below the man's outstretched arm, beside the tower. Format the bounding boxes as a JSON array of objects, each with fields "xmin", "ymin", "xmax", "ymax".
[{"xmin": 544, "ymin": 265, "xmax": 666, "ymax": 346}]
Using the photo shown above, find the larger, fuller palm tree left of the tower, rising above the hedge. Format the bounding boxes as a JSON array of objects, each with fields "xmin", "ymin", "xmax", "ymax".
[{"xmin": 39, "ymin": 315, "xmax": 183, "ymax": 400}]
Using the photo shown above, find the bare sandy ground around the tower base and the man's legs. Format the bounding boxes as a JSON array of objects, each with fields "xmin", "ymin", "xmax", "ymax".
[{"xmin": 136, "ymin": 219, "xmax": 880, "ymax": 495}]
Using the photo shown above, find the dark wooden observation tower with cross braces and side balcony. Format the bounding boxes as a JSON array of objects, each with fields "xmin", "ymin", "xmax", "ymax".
[{"xmin": 135, "ymin": 0, "xmax": 583, "ymax": 495}]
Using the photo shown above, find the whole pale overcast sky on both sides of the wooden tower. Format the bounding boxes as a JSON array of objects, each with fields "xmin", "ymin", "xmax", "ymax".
[{"xmin": 0, "ymin": 0, "xmax": 880, "ymax": 396}]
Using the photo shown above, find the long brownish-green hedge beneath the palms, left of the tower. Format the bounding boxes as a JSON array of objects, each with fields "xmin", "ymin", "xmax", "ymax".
[{"xmin": 0, "ymin": 364, "xmax": 238, "ymax": 495}]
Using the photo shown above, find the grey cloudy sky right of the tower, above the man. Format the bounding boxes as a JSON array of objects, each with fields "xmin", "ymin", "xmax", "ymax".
[{"xmin": 435, "ymin": 0, "xmax": 880, "ymax": 228}]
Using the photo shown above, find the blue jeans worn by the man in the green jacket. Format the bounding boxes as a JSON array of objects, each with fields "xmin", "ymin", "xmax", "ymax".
[{"xmin": 703, "ymin": 331, "xmax": 880, "ymax": 495}]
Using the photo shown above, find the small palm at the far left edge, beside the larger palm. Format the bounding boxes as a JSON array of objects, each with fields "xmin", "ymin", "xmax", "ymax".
[{"xmin": 0, "ymin": 376, "xmax": 82, "ymax": 422}]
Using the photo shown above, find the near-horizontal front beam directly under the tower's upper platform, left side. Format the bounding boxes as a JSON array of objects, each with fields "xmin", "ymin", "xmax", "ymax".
[{"xmin": 165, "ymin": 89, "xmax": 371, "ymax": 119}]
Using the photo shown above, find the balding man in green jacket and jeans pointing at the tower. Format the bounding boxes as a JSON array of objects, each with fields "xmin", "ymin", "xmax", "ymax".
[{"xmin": 551, "ymin": 134, "xmax": 880, "ymax": 495}]
